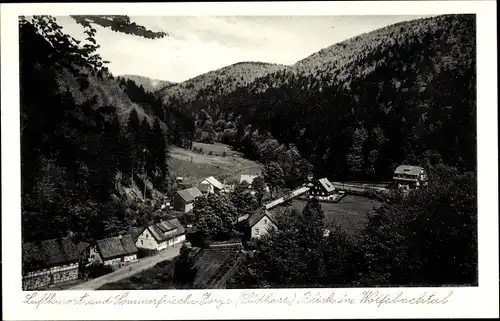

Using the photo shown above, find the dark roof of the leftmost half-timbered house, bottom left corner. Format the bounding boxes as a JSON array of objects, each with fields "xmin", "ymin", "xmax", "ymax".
[{"xmin": 23, "ymin": 237, "xmax": 80, "ymax": 270}]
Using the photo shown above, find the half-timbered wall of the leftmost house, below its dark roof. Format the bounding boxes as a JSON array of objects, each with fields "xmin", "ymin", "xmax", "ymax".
[{"xmin": 23, "ymin": 262, "xmax": 78, "ymax": 290}]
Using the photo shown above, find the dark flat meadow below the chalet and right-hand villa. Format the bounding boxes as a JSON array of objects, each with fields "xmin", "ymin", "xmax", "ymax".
[{"xmin": 277, "ymin": 195, "xmax": 380, "ymax": 235}]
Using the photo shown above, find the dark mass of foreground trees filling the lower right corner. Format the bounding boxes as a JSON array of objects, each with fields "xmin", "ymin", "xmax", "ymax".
[{"xmin": 228, "ymin": 164, "xmax": 478, "ymax": 288}]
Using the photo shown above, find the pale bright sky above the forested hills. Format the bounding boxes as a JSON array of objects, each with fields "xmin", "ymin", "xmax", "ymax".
[{"xmin": 56, "ymin": 16, "xmax": 430, "ymax": 82}]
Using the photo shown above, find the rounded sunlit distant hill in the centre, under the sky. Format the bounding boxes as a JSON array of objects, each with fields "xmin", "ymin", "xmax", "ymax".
[{"xmin": 157, "ymin": 62, "xmax": 285, "ymax": 102}]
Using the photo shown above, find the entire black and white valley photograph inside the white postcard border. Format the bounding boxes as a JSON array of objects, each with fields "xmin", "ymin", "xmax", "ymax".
[{"xmin": 2, "ymin": 1, "xmax": 498, "ymax": 318}]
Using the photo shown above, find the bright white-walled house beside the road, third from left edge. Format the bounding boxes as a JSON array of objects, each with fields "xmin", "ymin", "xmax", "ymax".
[{"xmin": 135, "ymin": 218, "xmax": 186, "ymax": 251}]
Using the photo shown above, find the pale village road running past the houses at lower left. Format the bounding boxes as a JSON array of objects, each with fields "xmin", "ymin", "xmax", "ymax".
[{"xmin": 69, "ymin": 244, "xmax": 182, "ymax": 290}]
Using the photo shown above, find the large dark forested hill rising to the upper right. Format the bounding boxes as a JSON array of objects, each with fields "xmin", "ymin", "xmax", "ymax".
[{"xmin": 185, "ymin": 15, "xmax": 476, "ymax": 180}]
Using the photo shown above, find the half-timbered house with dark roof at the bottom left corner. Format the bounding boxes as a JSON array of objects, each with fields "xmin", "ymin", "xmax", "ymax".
[{"xmin": 22, "ymin": 238, "xmax": 80, "ymax": 290}]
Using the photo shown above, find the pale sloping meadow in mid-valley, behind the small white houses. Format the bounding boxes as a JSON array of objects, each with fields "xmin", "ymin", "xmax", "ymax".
[{"xmin": 169, "ymin": 143, "xmax": 261, "ymax": 185}]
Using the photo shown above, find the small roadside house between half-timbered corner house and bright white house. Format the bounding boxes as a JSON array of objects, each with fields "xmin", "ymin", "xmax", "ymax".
[{"xmin": 90, "ymin": 234, "xmax": 138, "ymax": 268}]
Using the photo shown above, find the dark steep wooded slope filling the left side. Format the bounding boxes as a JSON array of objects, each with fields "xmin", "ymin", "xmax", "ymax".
[{"xmin": 19, "ymin": 16, "xmax": 172, "ymax": 242}]
